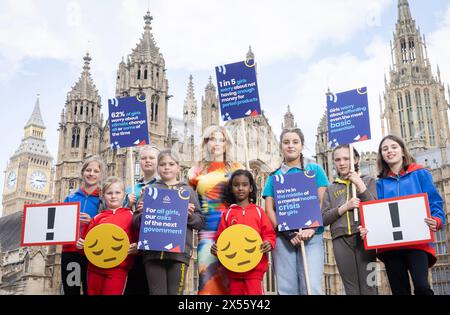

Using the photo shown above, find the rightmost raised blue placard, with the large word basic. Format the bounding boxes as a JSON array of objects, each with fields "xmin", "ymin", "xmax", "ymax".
[{"xmin": 327, "ymin": 87, "xmax": 371, "ymax": 148}]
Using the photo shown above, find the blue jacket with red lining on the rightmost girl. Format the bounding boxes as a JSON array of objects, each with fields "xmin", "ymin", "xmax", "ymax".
[{"xmin": 377, "ymin": 164, "xmax": 445, "ymax": 266}]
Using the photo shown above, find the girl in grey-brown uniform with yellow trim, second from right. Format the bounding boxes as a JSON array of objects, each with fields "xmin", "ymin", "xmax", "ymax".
[{"xmin": 322, "ymin": 145, "xmax": 377, "ymax": 295}]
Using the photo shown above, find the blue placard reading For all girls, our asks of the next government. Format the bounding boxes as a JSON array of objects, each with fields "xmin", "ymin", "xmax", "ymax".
[{"xmin": 138, "ymin": 187, "xmax": 189, "ymax": 253}]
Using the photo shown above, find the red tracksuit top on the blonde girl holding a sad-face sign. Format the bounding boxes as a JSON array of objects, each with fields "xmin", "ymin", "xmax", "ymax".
[{"xmin": 83, "ymin": 208, "xmax": 139, "ymax": 271}]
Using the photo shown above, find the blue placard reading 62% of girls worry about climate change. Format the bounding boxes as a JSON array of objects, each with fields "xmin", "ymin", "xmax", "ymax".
[{"xmin": 108, "ymin": 94, "xmax": 150, "ymax": 149}]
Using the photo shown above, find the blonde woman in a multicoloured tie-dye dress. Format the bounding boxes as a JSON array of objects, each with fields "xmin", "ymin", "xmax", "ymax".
[{"xmin": 189, "ymin": 126, "xmax": 243, "ymax": 295}]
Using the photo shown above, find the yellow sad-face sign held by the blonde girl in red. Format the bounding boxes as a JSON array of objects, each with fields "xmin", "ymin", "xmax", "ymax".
[{"xmin": 84, "ymin": 223, "xmax": 130, "ymax": 269}]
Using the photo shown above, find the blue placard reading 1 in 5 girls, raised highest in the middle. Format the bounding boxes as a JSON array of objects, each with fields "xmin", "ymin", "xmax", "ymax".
[{"xmin": 216, "ymin": 60, "xmax": 261, "ymax": 121}]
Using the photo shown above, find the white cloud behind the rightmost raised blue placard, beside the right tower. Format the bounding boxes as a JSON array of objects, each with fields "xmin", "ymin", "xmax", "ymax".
[{"xmin": 280, "ymin": 37, "xmax": 390, "ymax": 155}]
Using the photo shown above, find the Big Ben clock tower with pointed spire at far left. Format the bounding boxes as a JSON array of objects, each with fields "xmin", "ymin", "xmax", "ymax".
[{"xmin": 3, "ymin": 96, "xmax": 53, "ymax": 215}]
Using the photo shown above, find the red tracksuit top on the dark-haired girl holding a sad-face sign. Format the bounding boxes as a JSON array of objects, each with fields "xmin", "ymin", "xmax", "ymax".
[{"xmin": 216, "ymin": 203, "xmax": 276, "ymax": 280}]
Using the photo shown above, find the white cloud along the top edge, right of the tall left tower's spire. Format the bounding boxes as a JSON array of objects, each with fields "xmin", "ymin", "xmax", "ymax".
[{"xmin": 154, "ymin": 0, "xmax": 391, "ymax": 69}]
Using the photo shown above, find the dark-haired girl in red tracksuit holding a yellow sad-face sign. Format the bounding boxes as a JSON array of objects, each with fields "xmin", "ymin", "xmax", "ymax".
[{"xmin": 211, "ymin": 170, "xmax": 276, "ymax": 295}]
